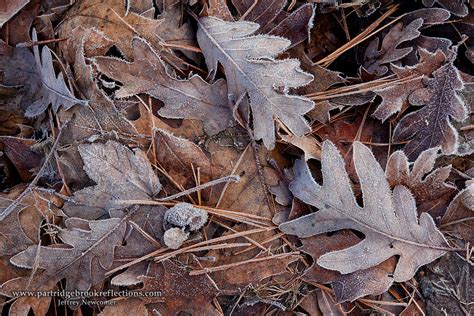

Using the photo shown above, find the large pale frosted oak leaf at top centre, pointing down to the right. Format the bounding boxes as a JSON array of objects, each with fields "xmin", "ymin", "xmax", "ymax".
[{"xmin": 197, "ymin": 17, "xmax": 314, "ymax": 148}]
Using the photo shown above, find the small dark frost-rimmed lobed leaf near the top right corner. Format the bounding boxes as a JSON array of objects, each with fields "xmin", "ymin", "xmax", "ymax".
[{"xmin": 363, "ymin": 18, "xmax": 423, "ymax": 76}]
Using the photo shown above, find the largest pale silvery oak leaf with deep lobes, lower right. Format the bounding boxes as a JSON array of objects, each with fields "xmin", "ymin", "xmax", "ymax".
[{"xmin": 280, "ymin": 141, "xmax": 447, "ymax": 282}]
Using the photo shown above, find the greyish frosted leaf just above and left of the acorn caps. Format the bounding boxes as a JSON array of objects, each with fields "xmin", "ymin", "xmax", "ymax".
[{"xmin": 64, "ymin": 141, "xmax": 161, "ymax": 219}]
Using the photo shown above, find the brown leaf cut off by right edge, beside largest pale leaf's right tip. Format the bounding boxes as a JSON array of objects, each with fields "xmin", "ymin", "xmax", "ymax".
[{"xmin": 441, "ymin": 184, "xmax": 474, "ymax": 243}]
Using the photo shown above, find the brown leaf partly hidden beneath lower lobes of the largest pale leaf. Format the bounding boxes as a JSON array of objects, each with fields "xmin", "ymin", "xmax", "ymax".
[{"xmin": 299, "ymin": 231, "xmax": 396, "ymax": 303}]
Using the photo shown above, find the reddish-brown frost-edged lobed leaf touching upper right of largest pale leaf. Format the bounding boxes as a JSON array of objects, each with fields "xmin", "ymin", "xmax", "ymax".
[{"xmin": 385, "ymin": 148, "xmax": 456, "ymax": 218}]
